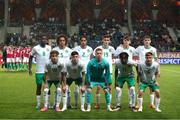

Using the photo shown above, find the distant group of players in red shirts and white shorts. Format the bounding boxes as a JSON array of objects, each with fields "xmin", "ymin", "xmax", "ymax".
[{"xmin": 3, "ymin": 45, "xmax": 32, "ymax": 70}]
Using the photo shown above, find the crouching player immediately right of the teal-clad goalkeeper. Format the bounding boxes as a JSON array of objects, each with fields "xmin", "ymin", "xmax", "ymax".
[{"xmin": 115, "ymin": 52, "xmax": 136, "ymax": 112}]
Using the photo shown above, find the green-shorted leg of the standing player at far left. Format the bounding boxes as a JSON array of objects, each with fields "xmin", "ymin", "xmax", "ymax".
[{"xmin": 36, "ymin": 73, "xmax": 44, "ymax": 109}]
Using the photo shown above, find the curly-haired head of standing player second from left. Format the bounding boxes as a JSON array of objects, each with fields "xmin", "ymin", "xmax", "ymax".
[{"xmin": 56, "ymin": 34, "xmax": 68, "ymax": 48}]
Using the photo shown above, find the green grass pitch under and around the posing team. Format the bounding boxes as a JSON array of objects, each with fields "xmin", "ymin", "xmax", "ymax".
[{"xmin": 0, "ymin": 65, "xmax": 180, "ymax": 119}]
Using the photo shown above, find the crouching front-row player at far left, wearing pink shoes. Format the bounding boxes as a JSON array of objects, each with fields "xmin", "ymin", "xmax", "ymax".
[{"xmin": 41, "ymin": 50, "xmax": 67, "ymax": 112}]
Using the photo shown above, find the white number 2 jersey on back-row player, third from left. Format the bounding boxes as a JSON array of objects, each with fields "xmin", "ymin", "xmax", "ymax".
[{"xmin": 73, "ymin": 46, "xmax": 93, "ymax": 69}]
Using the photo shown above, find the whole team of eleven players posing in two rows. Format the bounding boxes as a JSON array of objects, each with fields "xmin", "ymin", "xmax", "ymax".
[{"xmin": 29, "ymin": 35, "xmax": 161, "ymax": 112}]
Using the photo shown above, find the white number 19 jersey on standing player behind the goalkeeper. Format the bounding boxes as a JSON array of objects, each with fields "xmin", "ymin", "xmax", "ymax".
[{"xmin": 93, "ymin": 45, "xmax": 115, "ymax": 73}]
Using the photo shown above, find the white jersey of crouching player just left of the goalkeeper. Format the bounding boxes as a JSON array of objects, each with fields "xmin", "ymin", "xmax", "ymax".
[{"xmin": 64, "ymin": 60, "xmax": 85, "ymax": 79}]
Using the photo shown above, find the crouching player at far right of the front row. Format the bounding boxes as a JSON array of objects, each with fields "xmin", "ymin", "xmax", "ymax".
[{"xmin": 137, "ymin": 52, "xmax": 161, "ymax": 112}]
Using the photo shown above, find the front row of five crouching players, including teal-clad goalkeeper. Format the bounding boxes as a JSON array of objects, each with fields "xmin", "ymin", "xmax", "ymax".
[{"xmin": 38, "ymin": 48, "xmax": 161, "ymax": 112}]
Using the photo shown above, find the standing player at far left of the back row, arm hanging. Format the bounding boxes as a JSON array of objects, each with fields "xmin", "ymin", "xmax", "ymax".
[{"xmin": 29, "ymin": 36, "xmax": 51, "ymax": 109}]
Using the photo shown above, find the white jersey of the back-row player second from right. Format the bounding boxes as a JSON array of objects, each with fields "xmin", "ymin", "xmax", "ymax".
[{"xmin": 114, "ymin": 46, "xmax": 136, "ymax": 61}]
